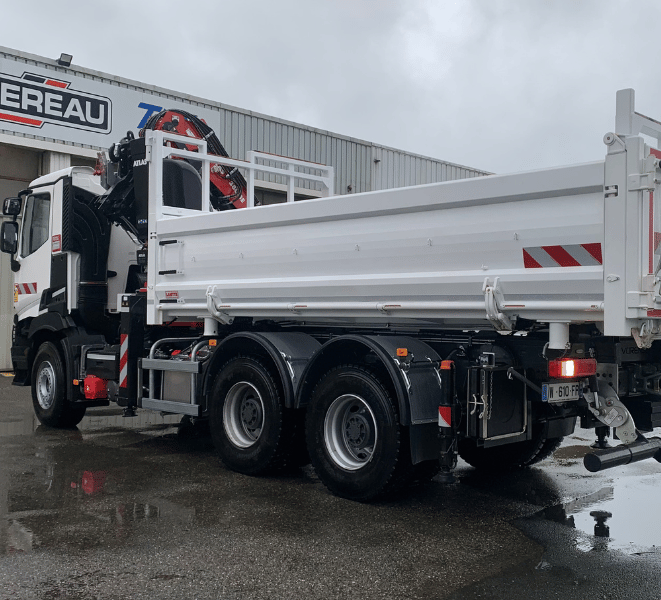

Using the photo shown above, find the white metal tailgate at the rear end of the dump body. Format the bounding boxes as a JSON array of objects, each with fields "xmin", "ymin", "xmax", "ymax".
[{"xmin": 604, "ymin": 90, "xmax": 661, "ymax": 347}]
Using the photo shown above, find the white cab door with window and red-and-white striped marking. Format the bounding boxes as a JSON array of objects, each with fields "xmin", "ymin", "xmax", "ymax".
[{"xmin": 14, "ymin": 186, "xmax": 53, "ymax": 320}]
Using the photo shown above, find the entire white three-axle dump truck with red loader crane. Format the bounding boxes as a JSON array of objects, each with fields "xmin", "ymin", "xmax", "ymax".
[{"xmin": 1, "ymin": 90, "xmax": 661, "ymax": 501}]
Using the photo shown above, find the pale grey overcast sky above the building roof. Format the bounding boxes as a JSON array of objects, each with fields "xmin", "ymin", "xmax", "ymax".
[{"xmin": 0, "ymin": 0, "xmax": 661, "ymax": 173}]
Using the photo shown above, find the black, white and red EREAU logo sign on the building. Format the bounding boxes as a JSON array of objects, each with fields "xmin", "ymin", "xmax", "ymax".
[{"xmin": 0, "ymin": 73, "xmax": 112, "ymax": 133}]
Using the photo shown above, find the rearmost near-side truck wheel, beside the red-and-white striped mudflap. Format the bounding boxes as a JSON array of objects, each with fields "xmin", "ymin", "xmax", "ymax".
[{"xmin": 306, "ymin": 365, "xmax": 413, "ymax": 501}]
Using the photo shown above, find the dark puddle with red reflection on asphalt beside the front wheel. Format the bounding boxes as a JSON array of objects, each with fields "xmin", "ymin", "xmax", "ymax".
[{"xmin": 0, "ymin": 400, "xmax": 196, "ymax": 556}]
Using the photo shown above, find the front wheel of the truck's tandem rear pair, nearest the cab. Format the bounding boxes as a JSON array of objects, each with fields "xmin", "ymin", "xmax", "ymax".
[{"xmin": 209, "ymin": 356, "xmax": 297, "ymax": 475}]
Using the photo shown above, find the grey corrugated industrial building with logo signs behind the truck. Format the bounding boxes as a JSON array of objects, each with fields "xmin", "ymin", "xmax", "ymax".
[{"xmin": 0, "ymin": 47, "xmax": 488, "ymax": 370}]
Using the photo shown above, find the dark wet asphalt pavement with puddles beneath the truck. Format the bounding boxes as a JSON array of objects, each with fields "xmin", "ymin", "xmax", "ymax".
[{"xmin": 0, "ymin": 376, "xmax": 661, "ymax": 600}]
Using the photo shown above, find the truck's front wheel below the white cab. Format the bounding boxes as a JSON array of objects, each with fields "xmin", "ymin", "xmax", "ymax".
[{"xmin": 32, "ymin": 342, "xmax": 85, "ymax": 428}]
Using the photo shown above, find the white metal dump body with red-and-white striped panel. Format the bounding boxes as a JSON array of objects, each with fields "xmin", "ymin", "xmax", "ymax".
[{"xmin": 147, "ymin": 88, "xmax": 661, "ymax": 342}]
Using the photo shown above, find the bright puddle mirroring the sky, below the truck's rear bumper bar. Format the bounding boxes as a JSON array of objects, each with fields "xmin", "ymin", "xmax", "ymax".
[{"xmin": 537, "ymin": 474, "xmax": 661, "ymax": 554}]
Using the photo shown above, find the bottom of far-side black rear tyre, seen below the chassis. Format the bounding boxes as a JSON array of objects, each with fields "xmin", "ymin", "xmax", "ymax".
[{"xmin": 458, "ymin": 425, "xmax": 564, "ymax": 472}]
